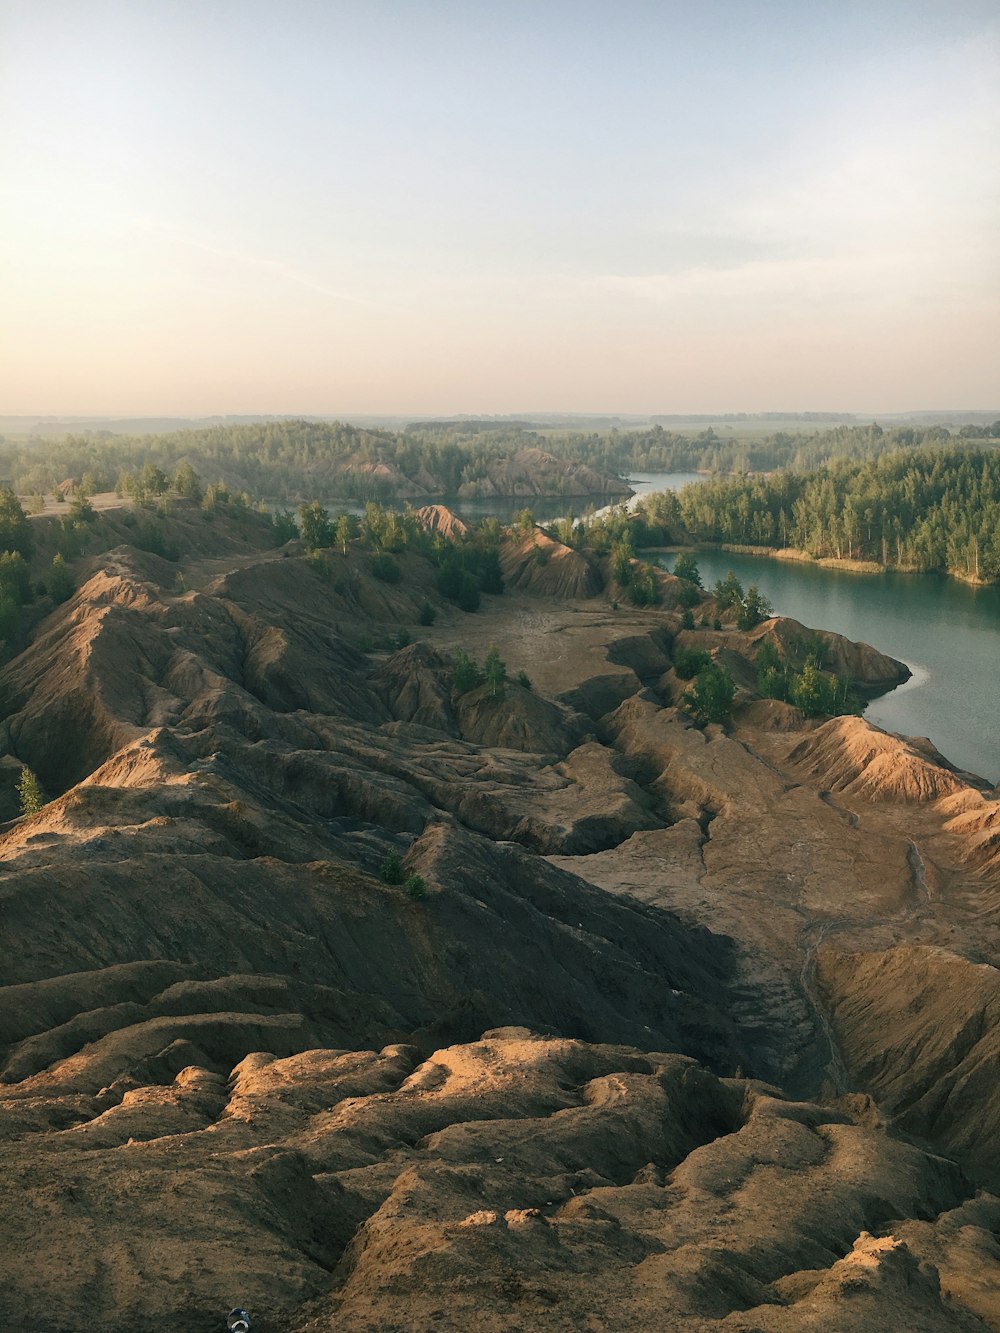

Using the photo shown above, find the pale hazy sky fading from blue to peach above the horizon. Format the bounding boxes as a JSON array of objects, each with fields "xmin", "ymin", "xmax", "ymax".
[{"xmin": 0, "ymin": 0, "xmax": 1000, "ymax": 415}]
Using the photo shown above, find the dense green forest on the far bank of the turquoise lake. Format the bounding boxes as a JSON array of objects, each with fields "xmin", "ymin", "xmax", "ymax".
[{"xmin": 640, "ymin": 441, "xmax": 1000, "ymax": 583}]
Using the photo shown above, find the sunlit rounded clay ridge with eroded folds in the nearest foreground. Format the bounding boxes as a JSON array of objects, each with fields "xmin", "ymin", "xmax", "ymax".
[{"xmin": 4, "ymin": 1028, "xmax": 1000, "ymax": 1333}]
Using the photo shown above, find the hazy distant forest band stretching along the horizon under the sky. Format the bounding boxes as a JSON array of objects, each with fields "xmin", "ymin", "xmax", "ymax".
[{"xmin": 0, "ymin": 420, "xmax": 1000, "ymax": 503}]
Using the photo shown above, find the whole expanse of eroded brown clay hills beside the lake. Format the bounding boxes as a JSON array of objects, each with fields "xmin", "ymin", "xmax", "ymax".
[{"xmin": 0, "ymin": 503, "xmax": 1000, "ymax": 1333}]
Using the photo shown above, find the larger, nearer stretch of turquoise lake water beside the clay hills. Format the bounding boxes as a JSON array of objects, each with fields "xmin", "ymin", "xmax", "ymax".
[{"xmin": 661, "ymin": 551, "xmax": 1000, "ymax": 782}]
